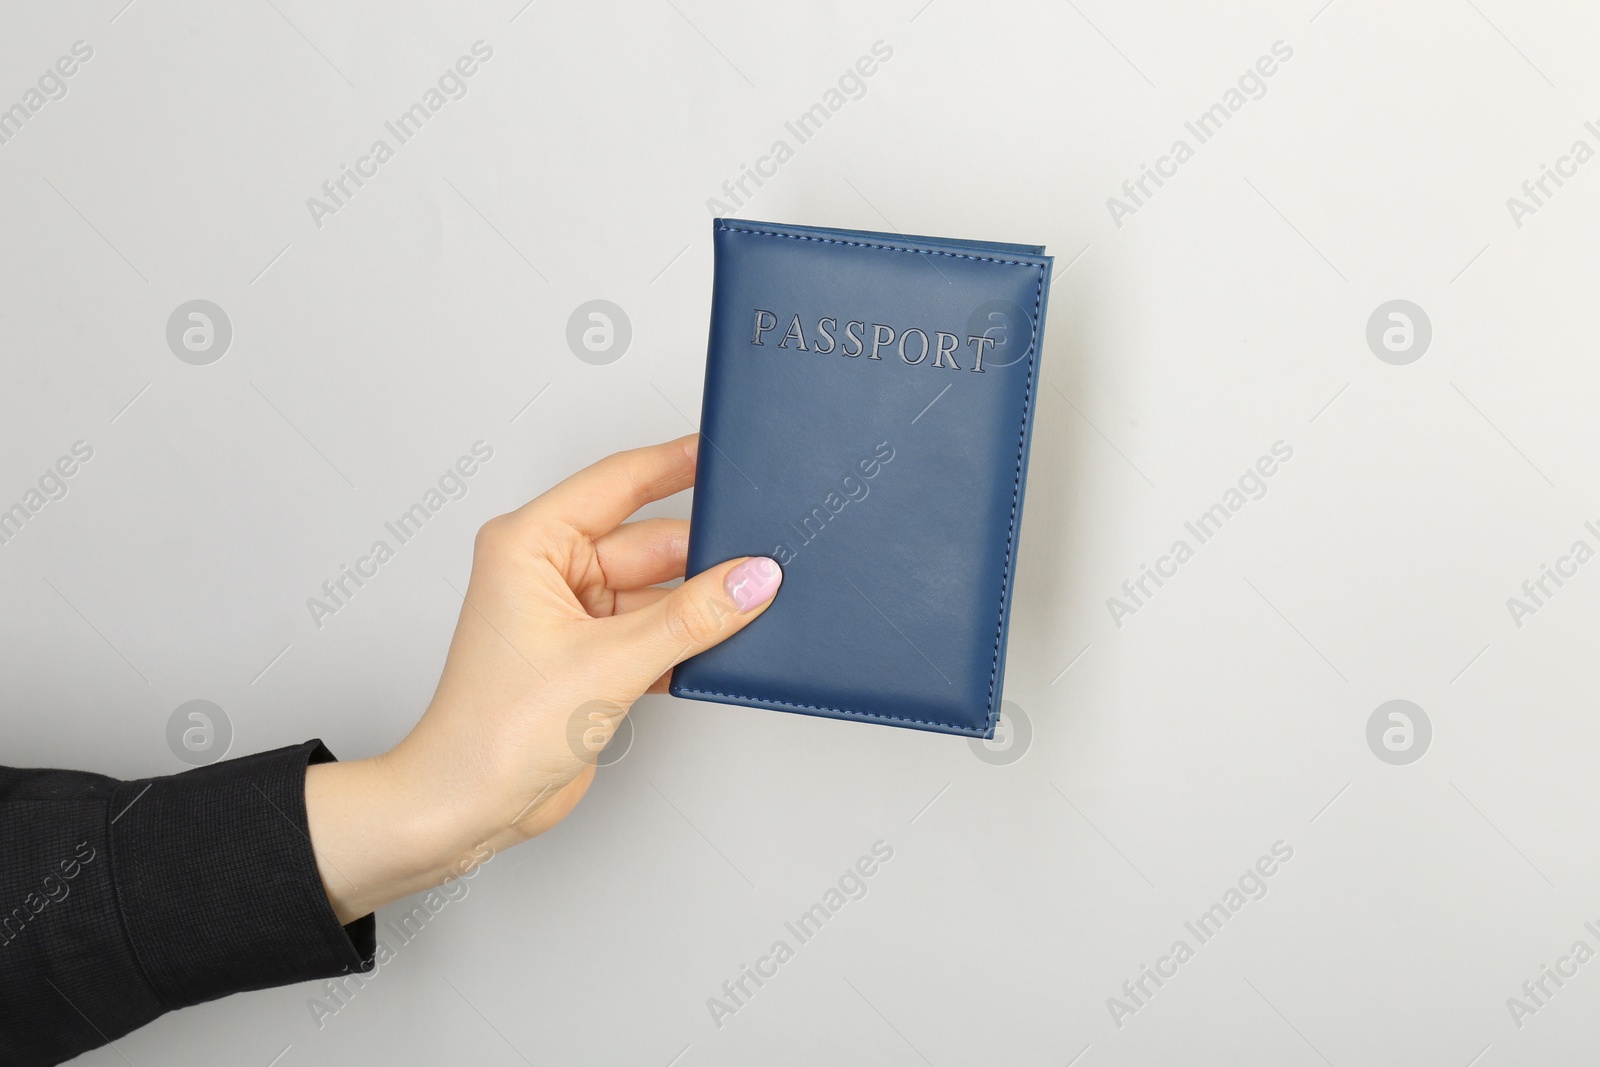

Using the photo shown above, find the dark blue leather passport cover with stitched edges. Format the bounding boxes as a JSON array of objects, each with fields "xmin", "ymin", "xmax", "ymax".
[{"xmin": 670, "ymin": 219, "xmax": 1053, "ymax": 737}]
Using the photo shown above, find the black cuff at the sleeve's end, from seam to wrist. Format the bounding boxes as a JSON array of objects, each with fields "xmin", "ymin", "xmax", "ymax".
[{"xmin": 106, "ymin": 741, "xmax": 374, "ymax": 1009}]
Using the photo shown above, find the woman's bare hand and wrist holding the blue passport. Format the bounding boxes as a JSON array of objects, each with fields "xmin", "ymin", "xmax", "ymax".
[{"xmin": 306, "ymin": 434, "xmax": 782, "ymax": 923}]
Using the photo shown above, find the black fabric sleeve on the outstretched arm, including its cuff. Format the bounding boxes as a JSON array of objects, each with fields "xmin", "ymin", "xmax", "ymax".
[{"xmin": 0, "ymin": 741, "xmax": 374, "ymax": 1067}]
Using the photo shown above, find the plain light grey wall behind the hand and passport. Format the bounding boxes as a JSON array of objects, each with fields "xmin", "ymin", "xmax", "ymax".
[{"xmin": 0, "ymin": 0, "xmax": 1600, "ymax": 1067}]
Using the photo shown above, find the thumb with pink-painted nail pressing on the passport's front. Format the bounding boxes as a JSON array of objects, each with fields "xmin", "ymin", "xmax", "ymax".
[{"xmin": 613, "ymin": 555, "xmax": 784, "ymax": 693}]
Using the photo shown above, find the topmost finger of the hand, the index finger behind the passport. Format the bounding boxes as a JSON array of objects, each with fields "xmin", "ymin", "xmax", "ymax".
[{"xmin": 507, "ymin": 434, "xmax": 699, "ymax": 537}]
